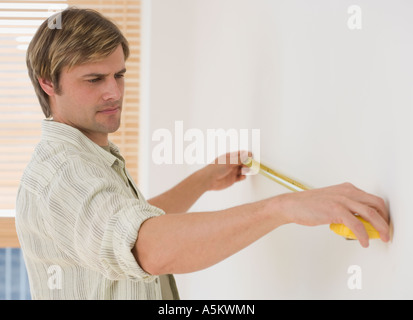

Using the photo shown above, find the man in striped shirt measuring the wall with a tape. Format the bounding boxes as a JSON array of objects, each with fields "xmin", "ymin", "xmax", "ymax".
[{"xmin": 16, "ymin": 8, "xmax": 389, "ymax": 299}]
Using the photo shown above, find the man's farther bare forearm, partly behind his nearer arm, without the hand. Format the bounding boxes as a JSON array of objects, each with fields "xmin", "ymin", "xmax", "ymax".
[{"xmin": 148, "ymin": 170, "xmax": 209, "ymax": 213}]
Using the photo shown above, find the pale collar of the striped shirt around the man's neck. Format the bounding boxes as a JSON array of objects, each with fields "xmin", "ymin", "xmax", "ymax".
[{"xmin": 42, "ymin": 119, "xmax": 120, "ymax": 166}]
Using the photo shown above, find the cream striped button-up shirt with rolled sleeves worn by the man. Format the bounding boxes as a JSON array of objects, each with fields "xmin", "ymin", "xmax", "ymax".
[{"xmin": 16, "ymin": 120, "xmax": 175, "ymax": 299}]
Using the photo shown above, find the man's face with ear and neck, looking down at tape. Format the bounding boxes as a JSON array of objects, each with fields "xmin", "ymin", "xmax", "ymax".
[{"xmin": 52, "ymin": 45, "xmax": 126, "ymax": 146}]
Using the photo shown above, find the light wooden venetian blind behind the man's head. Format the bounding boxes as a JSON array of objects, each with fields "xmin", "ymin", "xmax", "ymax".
[{"xmin": 0, "ymin": 0, "xmax": 141, "ymax": 216}]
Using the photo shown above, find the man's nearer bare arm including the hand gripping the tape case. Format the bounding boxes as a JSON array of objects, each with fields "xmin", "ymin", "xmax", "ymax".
[{"xmin": 132, "ymin": 183, "xmax": 389, "ymax": 274}]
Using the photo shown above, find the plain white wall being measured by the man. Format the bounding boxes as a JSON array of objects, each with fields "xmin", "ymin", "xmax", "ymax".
[{"xmin": 147, "ymin": 0, "xmax": 413, "ymax": 299}]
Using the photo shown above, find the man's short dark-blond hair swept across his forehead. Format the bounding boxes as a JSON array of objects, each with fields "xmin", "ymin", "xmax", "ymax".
[{"xmin": 26, "ymin": 7, "xmax": 129, "ymax": 118}]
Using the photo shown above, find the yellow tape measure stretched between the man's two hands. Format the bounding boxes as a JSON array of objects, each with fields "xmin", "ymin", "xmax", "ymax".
[{"xmin": 243, "ymin": 157, "xmax": 380, "ymax": 240}]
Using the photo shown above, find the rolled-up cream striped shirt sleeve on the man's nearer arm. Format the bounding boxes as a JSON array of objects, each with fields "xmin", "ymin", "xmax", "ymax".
[{"xmin": 41, "ymin": 159, "xmax": 165, "ymax": 281}]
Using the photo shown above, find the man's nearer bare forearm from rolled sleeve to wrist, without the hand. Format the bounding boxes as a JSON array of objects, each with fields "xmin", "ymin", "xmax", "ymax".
[{"xmin": 133, "ymin": 198, "xmax": 285, "ymax": 274}]
